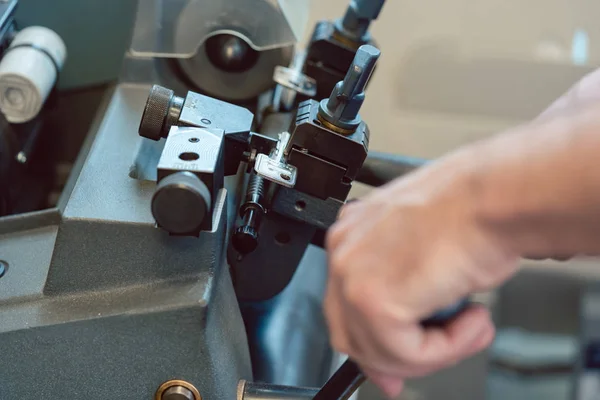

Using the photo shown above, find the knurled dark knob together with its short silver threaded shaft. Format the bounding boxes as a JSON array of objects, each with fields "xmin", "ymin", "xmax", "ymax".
[{"xmin": 138, "ymin": 85, "xmax": 183, "ymax": 140}]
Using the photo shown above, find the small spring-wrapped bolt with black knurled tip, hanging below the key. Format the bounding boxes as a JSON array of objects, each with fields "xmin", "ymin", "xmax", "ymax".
[{"xmin": 232, "ymin": 174, "xmax": 266, "ymax": 254}]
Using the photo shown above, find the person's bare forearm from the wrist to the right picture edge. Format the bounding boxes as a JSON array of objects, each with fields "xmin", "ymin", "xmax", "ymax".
[{"xmin": 466, "ymin": 106, "xmax": 600, "ymax": 256}]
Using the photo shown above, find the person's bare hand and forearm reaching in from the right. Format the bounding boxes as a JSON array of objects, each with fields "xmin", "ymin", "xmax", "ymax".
[{"xmin": 325, "ymin": 70, "xmax": 600, "ymax": 398}]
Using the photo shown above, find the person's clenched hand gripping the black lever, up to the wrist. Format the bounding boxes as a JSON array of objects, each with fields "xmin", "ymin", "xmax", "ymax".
[{"xmin": 325, "ymin": 153, "xmax": 518, "ymax": 397}]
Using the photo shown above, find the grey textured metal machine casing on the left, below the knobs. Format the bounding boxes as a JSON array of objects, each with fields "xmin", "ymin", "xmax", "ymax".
[{"xmin": 0, "ymin": 85, "xmax": 251, "ymax": 399}]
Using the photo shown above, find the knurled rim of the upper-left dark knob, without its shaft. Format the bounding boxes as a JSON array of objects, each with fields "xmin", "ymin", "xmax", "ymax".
[{"xmin": 138, "ymin": 85, "xmax": 175, "ymax": 140}]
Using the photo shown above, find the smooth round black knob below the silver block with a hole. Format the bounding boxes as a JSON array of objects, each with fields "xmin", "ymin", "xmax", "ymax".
[{"xmin": 152, "ymin": 172, "xmax": 211, "ymax": 235}]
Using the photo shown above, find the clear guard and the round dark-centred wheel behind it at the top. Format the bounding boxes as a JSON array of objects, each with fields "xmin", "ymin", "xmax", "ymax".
[{"xmin": 131, "ymin": 0, "xmax": 309, "ymax": 102}]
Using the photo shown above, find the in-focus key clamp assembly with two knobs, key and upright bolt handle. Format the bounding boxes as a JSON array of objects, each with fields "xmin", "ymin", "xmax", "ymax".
[{"xmin": 140, "ymin": 45, "xmax": 379, "ymax": 301}]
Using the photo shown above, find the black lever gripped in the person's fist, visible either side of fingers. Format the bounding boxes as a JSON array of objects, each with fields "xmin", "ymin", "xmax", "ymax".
[{"xmin": 313, "ymin": 299, "xmax": 469, "ymax": 400}]
